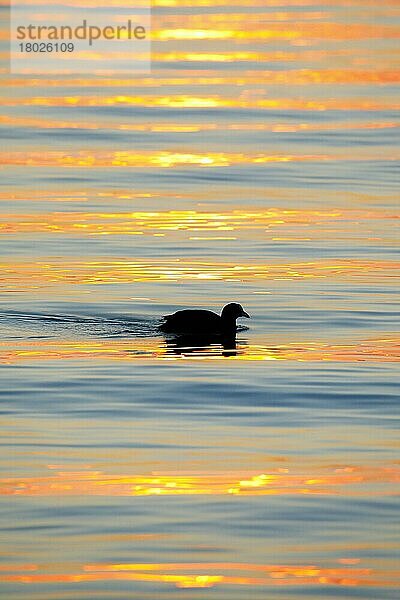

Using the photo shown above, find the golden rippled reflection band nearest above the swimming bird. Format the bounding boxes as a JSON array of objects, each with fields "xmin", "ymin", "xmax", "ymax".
[{"xmin": 0, "ymin": 258, "xmax": 400, "ymax": 291}]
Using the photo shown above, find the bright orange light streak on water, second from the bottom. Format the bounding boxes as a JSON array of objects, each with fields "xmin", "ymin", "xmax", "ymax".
[{"xmin": 0, "ymin": 464, "xmax": 400, "ymax": 496}]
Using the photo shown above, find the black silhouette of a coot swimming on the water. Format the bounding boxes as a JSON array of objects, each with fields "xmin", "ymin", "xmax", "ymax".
[{"xmin": 159, "ymin": 302, "xmax": 250, "ymax": 336}]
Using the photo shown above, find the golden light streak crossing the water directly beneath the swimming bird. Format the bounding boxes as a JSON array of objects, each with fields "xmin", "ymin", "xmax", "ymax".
[{"xmin": 0, "ymin": 334, "xmax": 400, "ymax": 364}]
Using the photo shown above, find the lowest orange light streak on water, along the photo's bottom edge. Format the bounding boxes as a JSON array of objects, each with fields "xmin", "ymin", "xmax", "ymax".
[{"xmin": 0, "ymin": 559, "xmax": 397, "ymax": 589}]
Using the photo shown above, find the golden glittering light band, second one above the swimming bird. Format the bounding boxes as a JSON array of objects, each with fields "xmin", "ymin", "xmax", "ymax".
[{"xmin": 0, "ymin": 207, "xmax": 400, "ymax": 243}]
